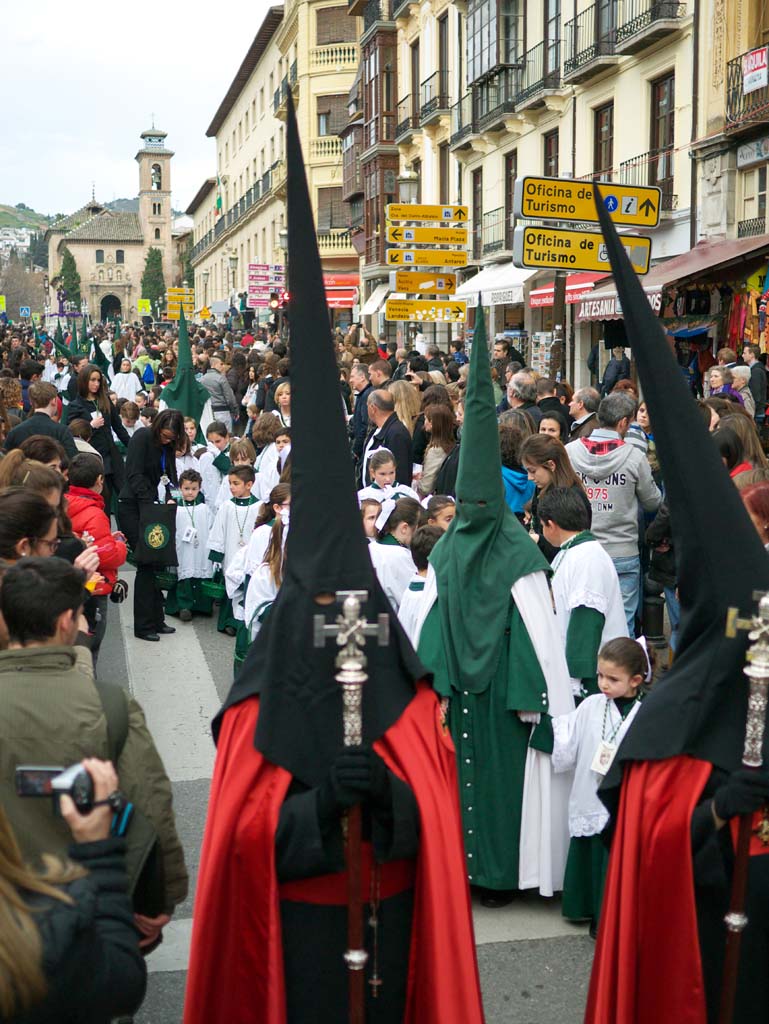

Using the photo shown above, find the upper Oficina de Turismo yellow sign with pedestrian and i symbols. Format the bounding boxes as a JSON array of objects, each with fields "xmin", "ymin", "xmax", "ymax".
[{"xmin": 513, "ymin": 175, "xmax": 661, "ymax": 227}]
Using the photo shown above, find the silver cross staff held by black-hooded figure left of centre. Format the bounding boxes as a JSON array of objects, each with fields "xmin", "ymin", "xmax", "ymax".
[{"xmin": 314, "ymin": 590, "xmax": 390, "ymax": 1024}]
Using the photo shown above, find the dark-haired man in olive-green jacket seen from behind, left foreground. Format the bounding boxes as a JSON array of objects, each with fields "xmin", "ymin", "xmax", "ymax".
[{"xmin": 0, "ymin": 557, "xmax": 187, "ymax": 949}]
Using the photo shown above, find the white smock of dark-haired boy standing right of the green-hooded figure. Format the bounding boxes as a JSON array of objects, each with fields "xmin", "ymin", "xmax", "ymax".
[{"xmin": 552, "ymin": 541, "xmax": 628, "ymax": 694}]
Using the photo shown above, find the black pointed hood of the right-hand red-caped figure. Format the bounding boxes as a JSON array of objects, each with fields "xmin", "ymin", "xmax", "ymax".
[{"xmin": 594, "ymin": 180, "xmax": 769, "ymax": 778}]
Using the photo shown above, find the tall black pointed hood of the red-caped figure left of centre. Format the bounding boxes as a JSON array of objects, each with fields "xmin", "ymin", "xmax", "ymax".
[{"xmin": 214, "ymin": 96, "xmax": 426, "ymax": 785}]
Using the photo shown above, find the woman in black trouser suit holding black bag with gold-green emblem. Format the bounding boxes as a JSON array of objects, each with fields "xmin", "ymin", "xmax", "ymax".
[{"xmin": 118, "ymin": 409, "xmax": 184, "ymax": 641}]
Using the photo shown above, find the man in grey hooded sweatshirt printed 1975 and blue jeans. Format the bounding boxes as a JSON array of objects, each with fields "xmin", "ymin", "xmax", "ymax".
[{"xmin": 566, "ymin": 391, "xmax": 661, "ymax": 636}]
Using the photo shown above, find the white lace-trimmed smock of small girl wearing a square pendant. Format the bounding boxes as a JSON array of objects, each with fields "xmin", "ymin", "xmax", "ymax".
[{"xmin": 553, "ymin": 693, "xmax": 641, "ymax": 837}]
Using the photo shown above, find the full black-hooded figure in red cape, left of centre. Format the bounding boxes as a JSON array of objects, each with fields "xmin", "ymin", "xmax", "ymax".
[{"xmin": 184, "ymin": 98, "xmax": 482, "ymax": 1024}]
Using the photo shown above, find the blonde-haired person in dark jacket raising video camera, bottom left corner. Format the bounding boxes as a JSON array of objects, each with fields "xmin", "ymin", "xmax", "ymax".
[{"xmin": 0, "ymin": 758, "xmax": 146, "ymax": 1024}]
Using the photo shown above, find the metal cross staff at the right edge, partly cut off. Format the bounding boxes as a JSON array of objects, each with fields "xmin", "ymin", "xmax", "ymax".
[{"xmin": 719, "ymin": 592, "xmax": 769, "ymax": 1024}]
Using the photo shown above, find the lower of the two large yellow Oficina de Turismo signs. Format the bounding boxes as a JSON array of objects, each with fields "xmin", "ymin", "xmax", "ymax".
[{"xmin": 513, "ymin": 226, "xmax": 651, "ymax": 273}]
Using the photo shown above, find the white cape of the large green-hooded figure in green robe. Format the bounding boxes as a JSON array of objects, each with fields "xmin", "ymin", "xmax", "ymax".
[{"xmin": 413, "ymin": 566, "xmax": 574, "ymax": 896}]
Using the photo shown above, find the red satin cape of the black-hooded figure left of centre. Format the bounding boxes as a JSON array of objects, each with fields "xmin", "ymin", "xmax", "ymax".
[{"xmin": 184, "ymin": 683, "xmax": 483, "ymax": 1024}]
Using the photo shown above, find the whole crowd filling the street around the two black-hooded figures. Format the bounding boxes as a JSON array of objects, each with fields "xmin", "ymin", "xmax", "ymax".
[{"xmin": 0, "ymin": 282, "xmax": 769, "ymax": 1021}]
